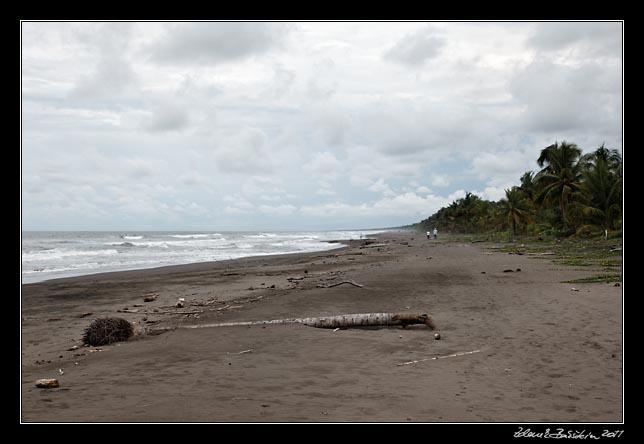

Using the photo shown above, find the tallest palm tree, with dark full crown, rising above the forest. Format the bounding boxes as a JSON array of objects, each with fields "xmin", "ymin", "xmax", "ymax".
[{"xmin": 536, "ymin": 141, "xmax": 581, "ymax": 227}]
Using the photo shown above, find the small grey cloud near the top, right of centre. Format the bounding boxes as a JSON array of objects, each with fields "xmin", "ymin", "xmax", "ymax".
[{"xmin": 384, "ymin": 27, "xmax": 445, "ymax": 67}]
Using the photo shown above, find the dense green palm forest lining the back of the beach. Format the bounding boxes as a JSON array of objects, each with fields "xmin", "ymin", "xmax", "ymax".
[{"xmin": 412, "ymin": 142, "xmax": 623, "ymax": 237}]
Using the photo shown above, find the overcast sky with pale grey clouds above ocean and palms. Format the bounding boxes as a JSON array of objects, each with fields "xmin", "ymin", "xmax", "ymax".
[{"xmin": 21, "ymin": 22, "xmax": 623, "ymax": 231}]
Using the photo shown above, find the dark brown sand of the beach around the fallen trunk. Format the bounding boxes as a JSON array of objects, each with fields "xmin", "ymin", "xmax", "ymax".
[{"xmin": 21, "ymin": 233, "xmax": 623, "ymax": 423}]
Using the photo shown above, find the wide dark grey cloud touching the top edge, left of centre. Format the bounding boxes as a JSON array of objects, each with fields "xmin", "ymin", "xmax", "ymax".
[{"xmin": 150, "ymin": 22, "xmax": 291, "ymax": 64}]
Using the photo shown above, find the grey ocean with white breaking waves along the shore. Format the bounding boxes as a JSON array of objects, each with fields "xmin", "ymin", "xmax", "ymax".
[{"xmin": 22, "ymin": 230, "xmax": 382, "ymax": 283}]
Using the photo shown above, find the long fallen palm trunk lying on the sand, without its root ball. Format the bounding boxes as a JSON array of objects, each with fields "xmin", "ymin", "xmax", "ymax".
[{"xmin": 148, "ymin": 313, "xmax": 436, "ymax": 331}]
